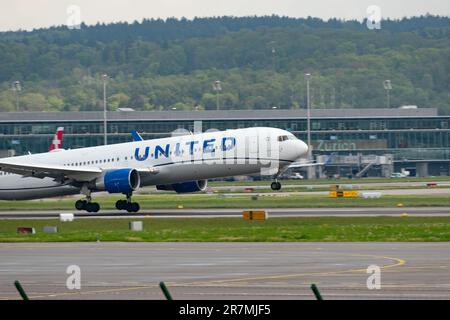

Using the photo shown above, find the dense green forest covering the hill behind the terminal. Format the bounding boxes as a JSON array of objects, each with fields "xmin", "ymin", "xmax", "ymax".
[{"xmin": 0, "ymin": 15, "xmax": 450, "ymax": 114}]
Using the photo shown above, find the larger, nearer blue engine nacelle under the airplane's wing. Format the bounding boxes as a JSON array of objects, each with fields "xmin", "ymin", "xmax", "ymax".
[{"xmin": 95, "ymin": 169, "xmax": 141, "ymax": 194}]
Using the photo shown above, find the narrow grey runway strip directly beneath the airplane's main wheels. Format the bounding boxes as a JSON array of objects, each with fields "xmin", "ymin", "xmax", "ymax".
[{"xmin": 0, "ymin": 207, "xmax": 450, "ymax": 219}]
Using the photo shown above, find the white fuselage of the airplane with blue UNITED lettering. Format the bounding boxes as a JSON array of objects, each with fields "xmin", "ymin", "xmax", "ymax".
[{"xmin": 0, "ymin": 128, "xmax": 308, "ymax": 200}]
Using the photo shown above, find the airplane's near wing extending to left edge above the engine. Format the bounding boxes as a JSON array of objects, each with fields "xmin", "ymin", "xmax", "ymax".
[{"xmin": 0, "ymin": 161, "xmax": 103, "ymax": 181}]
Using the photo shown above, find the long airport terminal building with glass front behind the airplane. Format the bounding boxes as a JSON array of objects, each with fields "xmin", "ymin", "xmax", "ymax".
[{"xmin": 0, "ymin": 108, "xmax": 450, "ymax": 177}]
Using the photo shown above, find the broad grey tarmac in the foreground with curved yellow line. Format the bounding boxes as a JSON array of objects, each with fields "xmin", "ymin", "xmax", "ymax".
[{"xmin": 0, "ymin": 243, "xmax": 450, "ymax": 300}]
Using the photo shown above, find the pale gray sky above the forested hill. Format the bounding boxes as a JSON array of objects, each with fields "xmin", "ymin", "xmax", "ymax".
[{"xmin": 0, "ymin": 0, "xmax": 450, "ymax": 31}]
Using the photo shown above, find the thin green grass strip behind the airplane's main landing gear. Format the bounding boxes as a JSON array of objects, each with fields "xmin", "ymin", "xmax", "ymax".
[{"xmin": 0, "ymin": 193, "xmax": 450, "ymax": 211}]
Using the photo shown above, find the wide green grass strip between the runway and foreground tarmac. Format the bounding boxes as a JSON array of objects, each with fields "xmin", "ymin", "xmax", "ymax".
[{"xmin": 0, "ymin": 217, "xmax": 450, "ymax": 242}]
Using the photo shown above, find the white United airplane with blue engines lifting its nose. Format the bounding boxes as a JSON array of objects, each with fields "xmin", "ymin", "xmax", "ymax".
[{"xmin": 0, "ymin": 127, "xmax": 308, "ymax": 212}]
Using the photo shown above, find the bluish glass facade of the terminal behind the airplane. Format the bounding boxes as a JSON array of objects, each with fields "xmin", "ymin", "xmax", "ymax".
[{"xmin": 0, "ymin": 112, "xmax": 450, "ymax": 161}]
